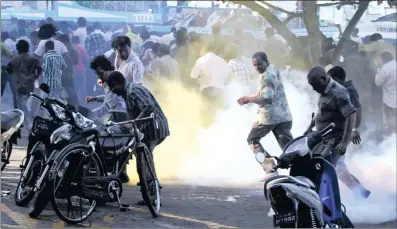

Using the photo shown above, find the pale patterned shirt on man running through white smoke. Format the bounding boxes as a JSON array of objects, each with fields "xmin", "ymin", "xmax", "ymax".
[{"xmin": 257, "ymin": 64, "xmax": 292, "ymax": 125}]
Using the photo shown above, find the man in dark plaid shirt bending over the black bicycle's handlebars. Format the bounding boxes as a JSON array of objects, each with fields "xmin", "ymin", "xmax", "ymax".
[{"xmin": 104, "ymin": 71, "xmax": 170, "ymax": 204}]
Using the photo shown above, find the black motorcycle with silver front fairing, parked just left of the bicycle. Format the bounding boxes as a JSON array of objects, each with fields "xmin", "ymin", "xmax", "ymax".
[{"xmin": 14, "ymin": 83, "xmax": 93, "ymax": 206}]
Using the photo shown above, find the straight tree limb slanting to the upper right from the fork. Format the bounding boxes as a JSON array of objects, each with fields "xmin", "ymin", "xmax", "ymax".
[{"xmin": 332, "ymin": 0, "xmax": 369, "ymax": 65}]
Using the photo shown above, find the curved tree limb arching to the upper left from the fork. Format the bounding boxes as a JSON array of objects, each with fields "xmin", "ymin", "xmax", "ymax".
[{"xmin": 230, "ymin": 1, "xmax": 310, "ymax": 68}]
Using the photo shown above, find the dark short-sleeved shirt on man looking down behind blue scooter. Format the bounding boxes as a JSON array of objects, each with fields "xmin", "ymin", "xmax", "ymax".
[{"xmin": 315, "ymin": 79, "xmax": 356, "ymax": 141}]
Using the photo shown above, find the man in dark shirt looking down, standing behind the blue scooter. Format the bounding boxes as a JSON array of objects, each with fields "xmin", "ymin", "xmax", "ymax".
[{"xmin": 307, "ymin": 66, "xmax": 356, "ymax": 166}]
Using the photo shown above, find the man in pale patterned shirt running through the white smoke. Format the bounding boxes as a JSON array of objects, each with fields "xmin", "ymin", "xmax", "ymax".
[{"xmin": 237, "ymin": 52, "xmax": 292, "ymax": 173}]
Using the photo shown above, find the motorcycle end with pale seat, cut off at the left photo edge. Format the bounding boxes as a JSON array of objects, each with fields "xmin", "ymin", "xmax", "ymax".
[{"xmin": 1, "ymin": 109, "xmax": 25, "ymax": 171}]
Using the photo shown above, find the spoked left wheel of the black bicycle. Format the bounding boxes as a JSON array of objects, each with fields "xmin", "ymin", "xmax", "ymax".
[{"xmin": 50, "ymin": 144, "xmax": 101, "ymax": 224}]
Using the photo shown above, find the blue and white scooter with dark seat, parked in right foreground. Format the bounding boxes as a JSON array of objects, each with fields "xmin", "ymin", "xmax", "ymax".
[{"xmin": 256, "ymin": 123, "xmax": 354, "ymax": 228}]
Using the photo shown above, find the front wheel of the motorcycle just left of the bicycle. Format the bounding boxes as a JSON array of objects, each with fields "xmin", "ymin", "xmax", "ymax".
[{"xmin": 14, "ymin": 158, "xmax": 44, "ymax": 207}]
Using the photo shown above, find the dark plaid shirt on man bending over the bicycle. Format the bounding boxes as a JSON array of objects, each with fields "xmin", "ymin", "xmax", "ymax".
[{"xmin": 123, "ymin": 83, "xmax": 170, "ymax": 141}]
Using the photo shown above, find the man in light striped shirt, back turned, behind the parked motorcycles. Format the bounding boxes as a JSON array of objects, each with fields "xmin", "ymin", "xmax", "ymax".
[{"xmin": 42, "ymin": 41, "xmax": 67, "ymax": 99}]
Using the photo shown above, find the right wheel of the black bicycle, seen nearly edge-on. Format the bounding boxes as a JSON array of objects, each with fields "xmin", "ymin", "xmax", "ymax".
[{"xmin": 136, "ymin": 143, "xmax": 161, "ymax": 217}]
